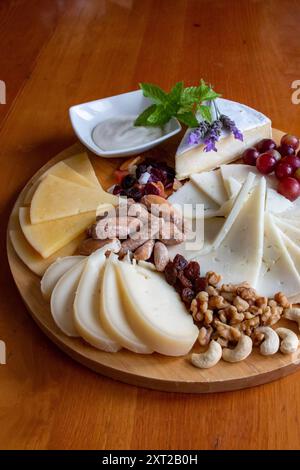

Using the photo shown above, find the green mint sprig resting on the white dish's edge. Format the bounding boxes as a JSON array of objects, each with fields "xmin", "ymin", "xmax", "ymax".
[{"xmin": 134, "ymin": 80, "xmax": 221, "ymax": 127}]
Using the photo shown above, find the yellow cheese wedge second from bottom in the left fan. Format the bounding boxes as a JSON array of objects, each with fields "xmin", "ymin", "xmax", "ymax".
[{"xmin": 19, "ymin": 207, "xmax": 96, "ymax": 258}]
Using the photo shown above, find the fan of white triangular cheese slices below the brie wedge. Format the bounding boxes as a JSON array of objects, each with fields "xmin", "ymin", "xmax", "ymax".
[{"xmin": 169, "ymin": 164, "xmax": 300, "ymax": 297}]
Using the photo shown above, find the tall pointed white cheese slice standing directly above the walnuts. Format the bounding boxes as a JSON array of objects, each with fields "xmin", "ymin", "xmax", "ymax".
[{"xmin": 195, "ymin": 178, "xmax": 266, "ymax": 287}]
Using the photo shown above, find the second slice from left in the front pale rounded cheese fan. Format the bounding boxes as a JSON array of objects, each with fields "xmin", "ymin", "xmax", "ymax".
[{"xmin": 50, "ymin": 259, "xmax": 87, "ymax": 337}]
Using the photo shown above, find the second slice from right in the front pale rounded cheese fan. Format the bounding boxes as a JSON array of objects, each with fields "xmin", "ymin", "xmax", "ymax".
[{"xmin": 100, "ymin": 256, "xmax": 153, "ymax": 354}]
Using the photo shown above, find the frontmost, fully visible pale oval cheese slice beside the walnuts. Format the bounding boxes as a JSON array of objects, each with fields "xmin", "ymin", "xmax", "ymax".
[{"xmin": 115, "ymin": 262, "xmax": 199, "ymax": 356}]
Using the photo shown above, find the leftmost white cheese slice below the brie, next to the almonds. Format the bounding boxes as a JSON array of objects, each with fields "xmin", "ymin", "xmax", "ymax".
[{"xmin": 168, "ymin": 181, "xmax": 219, "ymax": 217}]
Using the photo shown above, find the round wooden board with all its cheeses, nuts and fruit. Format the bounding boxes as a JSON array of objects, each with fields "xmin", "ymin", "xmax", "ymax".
[{"xmin": 7, "ymin": 82, "xmax": 300, "ymax": 393}]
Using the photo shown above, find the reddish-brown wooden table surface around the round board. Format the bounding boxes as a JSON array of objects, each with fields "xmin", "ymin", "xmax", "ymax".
[{"xmin": 0, "ymin": 0, "xmax": 300, "ymax": 449}]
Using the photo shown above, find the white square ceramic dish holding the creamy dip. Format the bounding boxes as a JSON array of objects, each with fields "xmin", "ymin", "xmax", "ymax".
[{"xmin": 69, "ymin": 90, "xmax": 181, "ymax": 158}]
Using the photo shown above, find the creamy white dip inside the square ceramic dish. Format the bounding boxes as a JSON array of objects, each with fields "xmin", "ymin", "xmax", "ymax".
[{"xmin": 92, "ymin": 116, "xmax": 163, "ymax": 150}]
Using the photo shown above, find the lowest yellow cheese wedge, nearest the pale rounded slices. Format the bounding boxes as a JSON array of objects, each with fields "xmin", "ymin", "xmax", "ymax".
[{"xmin": 9, "ymin": 228, "xmax": 84, "ymax": 276}]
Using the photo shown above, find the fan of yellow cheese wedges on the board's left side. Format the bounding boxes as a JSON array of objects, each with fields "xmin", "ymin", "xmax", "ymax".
[{"xmin": 10, "ymin": 153, "xmax": 118, "ymax": 275}]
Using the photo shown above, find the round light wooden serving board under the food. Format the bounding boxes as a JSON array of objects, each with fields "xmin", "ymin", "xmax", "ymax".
[{"xmin": 7, "ymin": 131, "xmax": 300, "ymax": 393}]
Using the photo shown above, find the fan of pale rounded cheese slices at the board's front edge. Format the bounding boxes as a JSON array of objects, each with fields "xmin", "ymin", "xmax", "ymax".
[{"xmin": 41, "ymin": 240, "xmax": 198, "ymax": 356}]
